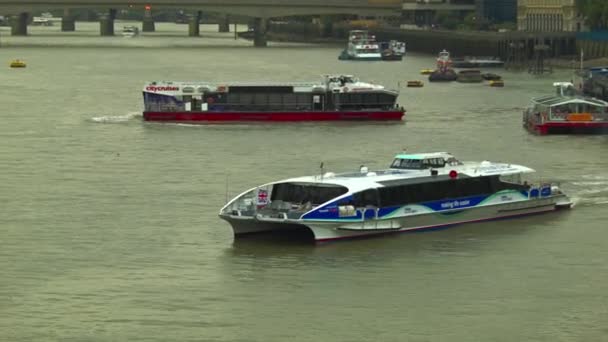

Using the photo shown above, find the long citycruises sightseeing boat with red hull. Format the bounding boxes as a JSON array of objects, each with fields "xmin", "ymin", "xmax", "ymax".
[{"xmin": 143, "ymin": 75, "xmax": 405, "ymax": 123}]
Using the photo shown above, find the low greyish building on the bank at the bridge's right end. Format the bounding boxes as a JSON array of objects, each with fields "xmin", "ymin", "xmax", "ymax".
[{"xmin": 402, "ymin": 0, "xmax": 476, "ymax": 26}]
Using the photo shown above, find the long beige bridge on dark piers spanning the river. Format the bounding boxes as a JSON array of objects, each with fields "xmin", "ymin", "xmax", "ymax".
[{"xmin": 0, "ymin": 0, "xmax": 402, "ymax": 46}]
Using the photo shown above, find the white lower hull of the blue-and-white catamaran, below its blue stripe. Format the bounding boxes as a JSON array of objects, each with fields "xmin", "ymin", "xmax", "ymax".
[{"xmin": 222, "ymin": 195, "xmax": 572, "ymax": 242}]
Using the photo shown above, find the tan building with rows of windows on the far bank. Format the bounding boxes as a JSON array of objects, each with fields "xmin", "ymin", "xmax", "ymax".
[{"xmin": 517, "ymin": 0, "xmax": 583, "ymax": 32}]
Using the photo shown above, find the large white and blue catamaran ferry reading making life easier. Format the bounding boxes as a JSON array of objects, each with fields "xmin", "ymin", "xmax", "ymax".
[{"xmin": 219, "ymin": 152, "xmax": 572, "ymax": 241}]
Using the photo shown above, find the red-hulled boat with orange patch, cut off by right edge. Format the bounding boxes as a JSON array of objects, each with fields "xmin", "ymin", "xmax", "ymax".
[{"xmin": 523, "ymin": 82, "xmax": 608, "ymax": 134}]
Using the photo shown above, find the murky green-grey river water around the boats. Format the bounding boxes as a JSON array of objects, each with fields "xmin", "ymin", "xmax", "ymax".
[{"xmin": 0, "ymin": 23, "xmax": 608, "ymax": 342}]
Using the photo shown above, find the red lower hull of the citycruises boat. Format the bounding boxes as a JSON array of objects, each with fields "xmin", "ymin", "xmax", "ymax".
[{"xmin": 144, "ymin": 110, "xmax": 404, "ymax": 123}]
